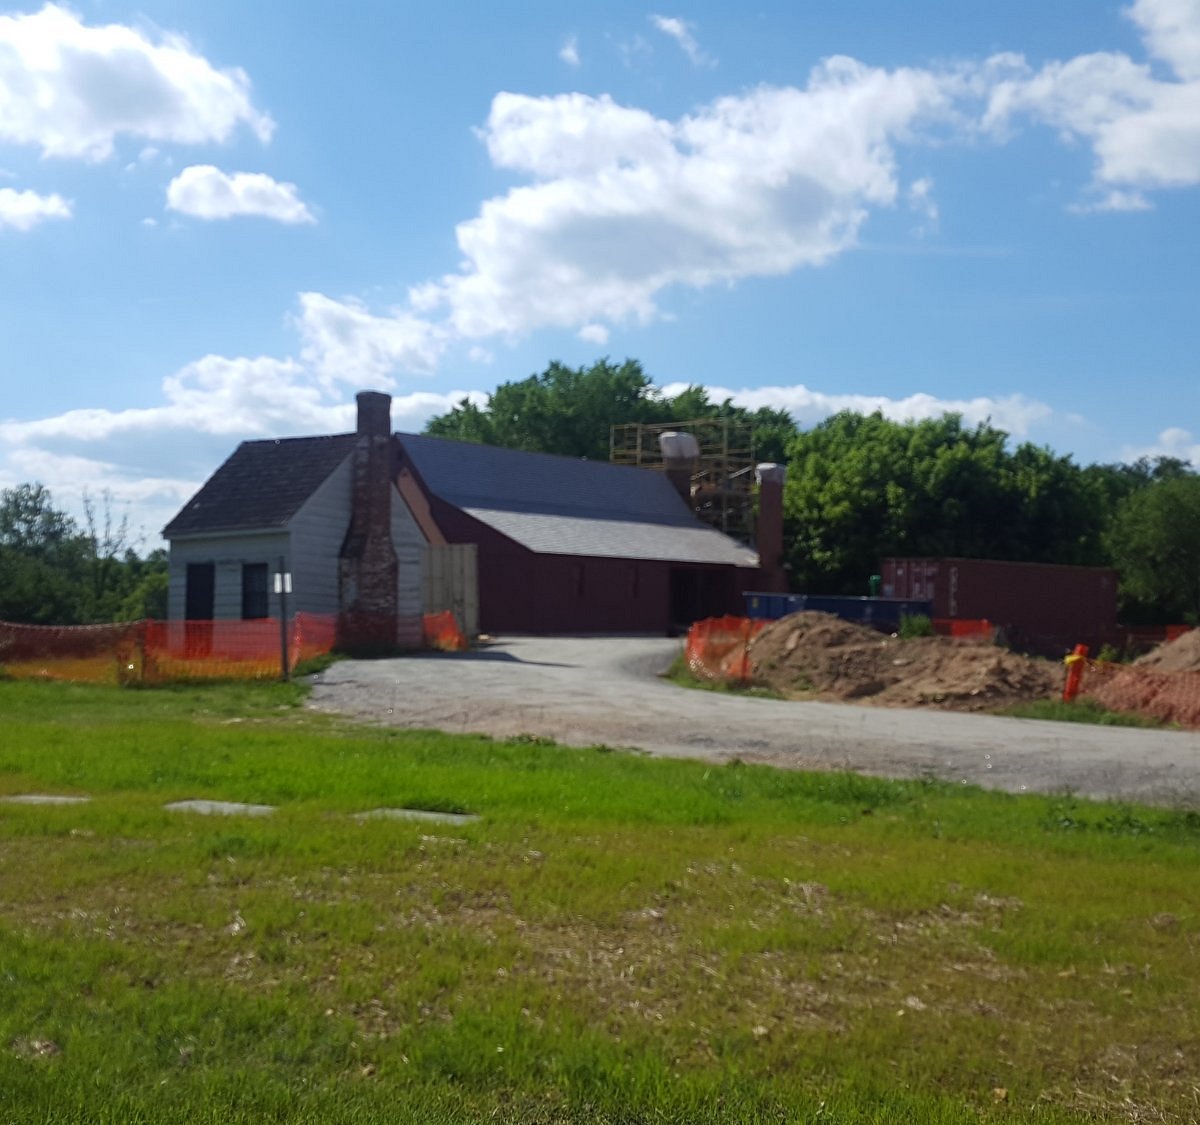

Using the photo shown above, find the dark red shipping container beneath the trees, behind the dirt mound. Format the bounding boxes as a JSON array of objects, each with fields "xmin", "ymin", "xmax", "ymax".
[{"xmin": 882, "ymin": 559, "xmax": 1117, "ymax": 655}]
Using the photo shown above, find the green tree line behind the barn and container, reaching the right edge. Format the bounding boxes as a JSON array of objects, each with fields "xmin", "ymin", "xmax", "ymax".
[{"xmin": 426, "ymin": 360, "xmax": 1200, "ymax": 624}]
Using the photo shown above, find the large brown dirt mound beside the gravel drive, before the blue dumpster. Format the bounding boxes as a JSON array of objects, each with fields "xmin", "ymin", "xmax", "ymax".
[{"xmin": 750, "ymin": 613, "xmax": 1063, "ymax": 711}]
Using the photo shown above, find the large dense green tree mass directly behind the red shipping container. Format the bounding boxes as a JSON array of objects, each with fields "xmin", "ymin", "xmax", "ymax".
[{"xmin": 785, "ymin": 411, "xmax": 1104, "ymax": 594}]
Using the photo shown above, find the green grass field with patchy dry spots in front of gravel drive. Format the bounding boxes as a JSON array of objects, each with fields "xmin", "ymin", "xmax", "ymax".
[{"xmin": 0, "ymin": 682, "xmax": 1200, "ymax": 1125}]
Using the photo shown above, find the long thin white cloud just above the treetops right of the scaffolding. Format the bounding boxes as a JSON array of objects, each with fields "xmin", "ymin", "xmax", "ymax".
[{"xmin": 662, "ymin": 383, "xmax": 1055, "ymax": 438}]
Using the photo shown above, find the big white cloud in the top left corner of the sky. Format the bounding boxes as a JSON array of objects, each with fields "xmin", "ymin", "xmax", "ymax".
[{"xmin": 0, "ymin": 4, "xmax": 274, "ymax": 161}]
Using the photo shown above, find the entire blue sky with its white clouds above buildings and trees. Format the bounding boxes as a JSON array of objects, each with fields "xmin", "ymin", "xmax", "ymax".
[{"xmin": 0, "ymin": 0, "xmax": 1200, "ymax": 546}]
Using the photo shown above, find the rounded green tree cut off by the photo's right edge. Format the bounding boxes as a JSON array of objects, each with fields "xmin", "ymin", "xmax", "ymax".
[{"xmin": 1108, "ymin": 470, "xmax": 1200, "ymax": 624}]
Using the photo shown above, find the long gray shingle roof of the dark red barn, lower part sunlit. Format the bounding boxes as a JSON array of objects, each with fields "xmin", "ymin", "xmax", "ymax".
[{"xmin": 397, "ymin": 434, "xmax": 758, "ymax": 566}]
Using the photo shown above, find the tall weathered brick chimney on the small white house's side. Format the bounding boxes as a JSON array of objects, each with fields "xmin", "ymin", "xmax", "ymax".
[{"xmin": 337, "ymin": 391, "xmax": 400, "ymax": 654}]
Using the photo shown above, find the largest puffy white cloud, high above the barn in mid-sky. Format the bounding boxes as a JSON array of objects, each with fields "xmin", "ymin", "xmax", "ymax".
[{"xmin": 414, "ymin": 59, "xmax": 959, "ymax": 338}]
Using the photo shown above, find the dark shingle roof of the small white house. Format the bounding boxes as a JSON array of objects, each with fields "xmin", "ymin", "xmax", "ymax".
[{"xmin": 162, "ymin": 434, "xmax": 354, "ymax": 539}]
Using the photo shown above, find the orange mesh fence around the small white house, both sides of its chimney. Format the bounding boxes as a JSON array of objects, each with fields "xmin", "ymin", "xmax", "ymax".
[{"xmin": 0, "ymin": 613, "xmax": 468, "ymax": 684}]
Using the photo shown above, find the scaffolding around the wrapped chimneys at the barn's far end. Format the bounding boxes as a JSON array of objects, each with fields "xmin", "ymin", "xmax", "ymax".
[{"xmin": 608, "ymin": 417, "xmax": 755, "ymax": 542}]
